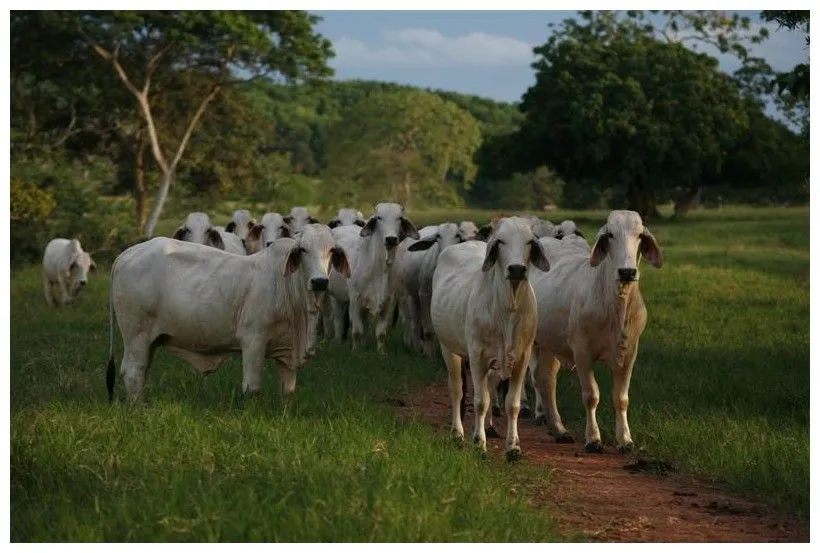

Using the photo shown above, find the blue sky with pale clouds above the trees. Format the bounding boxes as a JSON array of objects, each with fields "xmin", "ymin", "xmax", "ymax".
[{"xmin": 313, "ymin": 11, "xmax": 809, "ymax": 105}]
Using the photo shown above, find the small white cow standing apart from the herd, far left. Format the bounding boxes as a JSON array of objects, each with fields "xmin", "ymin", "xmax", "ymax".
[{"xmin": 43, "ymin": 238, "xmax": 97, "ymax": 306}]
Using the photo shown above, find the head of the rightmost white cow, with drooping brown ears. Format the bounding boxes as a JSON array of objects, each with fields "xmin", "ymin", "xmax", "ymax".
[{"xmin": 589, "ymin": 210, "xmax": 663, "ymax": 285}]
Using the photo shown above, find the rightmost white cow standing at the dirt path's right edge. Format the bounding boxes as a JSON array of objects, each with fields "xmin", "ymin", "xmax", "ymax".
[{"xmin": 530, "ymin": 211, "xmax": 663, "ymax": 452}]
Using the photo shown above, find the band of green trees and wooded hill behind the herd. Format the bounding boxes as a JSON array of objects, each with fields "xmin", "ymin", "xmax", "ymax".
[{"xmin": 10, "ymin": 11, "xmax": 809, "ymax": 259}]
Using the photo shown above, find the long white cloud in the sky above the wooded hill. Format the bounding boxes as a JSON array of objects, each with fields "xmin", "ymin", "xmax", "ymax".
[{"xmin": 333, "ymin": 28, "xmax": 533, "ymax": 67}]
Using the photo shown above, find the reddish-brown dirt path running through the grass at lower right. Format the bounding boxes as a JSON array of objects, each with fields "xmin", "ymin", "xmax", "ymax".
[{"xmin": 399, "ymin": 381, "xmax": 809, "ymax": 542}]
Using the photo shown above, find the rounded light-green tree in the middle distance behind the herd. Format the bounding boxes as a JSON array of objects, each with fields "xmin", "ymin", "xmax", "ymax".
[{"xmin": 325, "ymin": 90, "xmax": 481, "ymax": 206}]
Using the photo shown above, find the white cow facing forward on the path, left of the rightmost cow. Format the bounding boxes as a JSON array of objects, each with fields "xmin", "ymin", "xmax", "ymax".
[{"xmin": 430, "ymin": 217, "xmax": 550, "ymax": 461}]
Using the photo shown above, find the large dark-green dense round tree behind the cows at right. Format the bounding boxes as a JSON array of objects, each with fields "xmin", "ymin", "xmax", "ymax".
[{"xmin": 519, "ymin": 13, "xmax": 746, "ymax": 217}]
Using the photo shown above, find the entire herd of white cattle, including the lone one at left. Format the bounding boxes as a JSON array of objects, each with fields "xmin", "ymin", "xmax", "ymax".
[{"xmin": 43, "ymin": 203, "xmax": 663, "ymax": 460}]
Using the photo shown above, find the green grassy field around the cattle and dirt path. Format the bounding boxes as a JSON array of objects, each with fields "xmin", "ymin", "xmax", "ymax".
[{"xmin": 10, "ymin": 204, "xmax": 809, "ymax": 542}]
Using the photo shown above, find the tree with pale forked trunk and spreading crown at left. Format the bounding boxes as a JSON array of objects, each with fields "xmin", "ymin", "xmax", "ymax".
[{"xmin": 12, "ymin": 11, "xmax": 332, "ymax": 236}]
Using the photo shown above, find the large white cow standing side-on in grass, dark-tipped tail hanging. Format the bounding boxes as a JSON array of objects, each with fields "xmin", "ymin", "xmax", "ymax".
[{"xmin": 107, "ymin": 225, "xmax": 349, "ymax": 400}]
